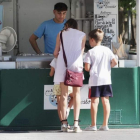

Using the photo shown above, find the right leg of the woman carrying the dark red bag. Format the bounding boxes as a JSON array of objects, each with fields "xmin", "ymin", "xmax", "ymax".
[{"xmin": 73, "ymin": 87, "xmax": 81, "ymax": 126}]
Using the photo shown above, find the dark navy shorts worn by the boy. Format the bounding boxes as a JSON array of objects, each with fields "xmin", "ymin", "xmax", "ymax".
[{"xmin": 91, "ymin": 85, "xmax": 113, "ymax": 98}]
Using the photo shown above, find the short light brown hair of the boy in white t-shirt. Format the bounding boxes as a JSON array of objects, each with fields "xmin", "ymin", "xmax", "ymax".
[{"xmin": 89, "ymin": 29, "xmax": 104, "ymax": 43}]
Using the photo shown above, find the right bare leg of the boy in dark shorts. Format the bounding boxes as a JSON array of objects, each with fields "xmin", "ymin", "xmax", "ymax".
[{"xmin": 101, "ymin": 97, "xmax": 110, "ymax": 126}]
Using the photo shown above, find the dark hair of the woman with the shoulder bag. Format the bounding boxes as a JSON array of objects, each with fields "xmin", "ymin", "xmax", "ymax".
[{"xmin": 65, "ymin": 18, "xmax": 78, "ymax": 29}]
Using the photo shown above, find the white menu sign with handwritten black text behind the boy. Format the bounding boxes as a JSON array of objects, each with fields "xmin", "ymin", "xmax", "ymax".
[{"xmin": 94, "ymin": 0, "xmax": 118, "ymax": 48}]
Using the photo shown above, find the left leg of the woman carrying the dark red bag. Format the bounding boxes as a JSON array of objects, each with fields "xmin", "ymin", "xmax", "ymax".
[{"xmin": 60, "ymin": 83, "xmax": 68, "ymax": 124}]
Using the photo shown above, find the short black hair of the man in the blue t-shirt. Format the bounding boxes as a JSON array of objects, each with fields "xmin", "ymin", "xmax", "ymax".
[{"xmin": 54, "ymin": 2, "xmax": 68, "ymax": 11}]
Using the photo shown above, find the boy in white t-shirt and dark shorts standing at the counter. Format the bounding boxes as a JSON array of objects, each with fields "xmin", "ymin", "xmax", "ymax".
[{"xmin": 84, "ymin": 29, "xmax": 117, "ymax": 131}]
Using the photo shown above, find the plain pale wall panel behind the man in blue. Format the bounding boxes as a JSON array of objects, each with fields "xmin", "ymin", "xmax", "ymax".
[{"xmin": 19, "ymin": 0, "xmax": 70, "ymax": 53}]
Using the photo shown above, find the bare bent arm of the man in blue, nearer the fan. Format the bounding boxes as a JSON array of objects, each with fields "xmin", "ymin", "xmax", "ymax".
[{"xmin": 29, "ymin": 34, "xmax": 42, "ymax": 54}]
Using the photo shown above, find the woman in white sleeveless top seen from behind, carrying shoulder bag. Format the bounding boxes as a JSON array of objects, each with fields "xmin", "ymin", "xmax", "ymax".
[{"xmin": 54, "ymin": 19, "xmax": 86, "ymax": 132}]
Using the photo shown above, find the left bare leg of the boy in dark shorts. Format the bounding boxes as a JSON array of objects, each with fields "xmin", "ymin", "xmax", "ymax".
[{"xmin": 91, "ymin": 97, "xmax": 99, "ymax": 126}]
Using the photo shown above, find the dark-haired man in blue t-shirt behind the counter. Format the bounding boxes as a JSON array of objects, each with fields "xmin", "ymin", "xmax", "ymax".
[{"xmin": 29, "ymin": 2, "xmax": 68, "ymax": 54}]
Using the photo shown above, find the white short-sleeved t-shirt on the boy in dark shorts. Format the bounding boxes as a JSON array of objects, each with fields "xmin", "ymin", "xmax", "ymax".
[{"xmin": 84, "ymin": 46, "xmax": 115, "ymax": 86}]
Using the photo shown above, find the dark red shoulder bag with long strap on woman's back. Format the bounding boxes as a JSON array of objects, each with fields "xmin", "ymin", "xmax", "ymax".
[{"xmin": 60, "ymin": 32, "xmax": 83, "ymax": 87}]
